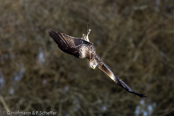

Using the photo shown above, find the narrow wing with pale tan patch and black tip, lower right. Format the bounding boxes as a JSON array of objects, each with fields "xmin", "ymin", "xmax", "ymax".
[{"xmin": 97, "ymin": 55, "xmax": 146, "ymax": 97}]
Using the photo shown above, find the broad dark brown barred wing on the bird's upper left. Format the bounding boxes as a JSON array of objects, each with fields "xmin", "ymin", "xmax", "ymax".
[{"xmin": 49, "ymin": 30, "xmax": 90, "ymax": 58}]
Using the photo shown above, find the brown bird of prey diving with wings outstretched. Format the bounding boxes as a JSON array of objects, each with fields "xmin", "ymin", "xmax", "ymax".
[{"xmin": 49, "ymin": 29, "xmax": 146, "ymax": 98}]
